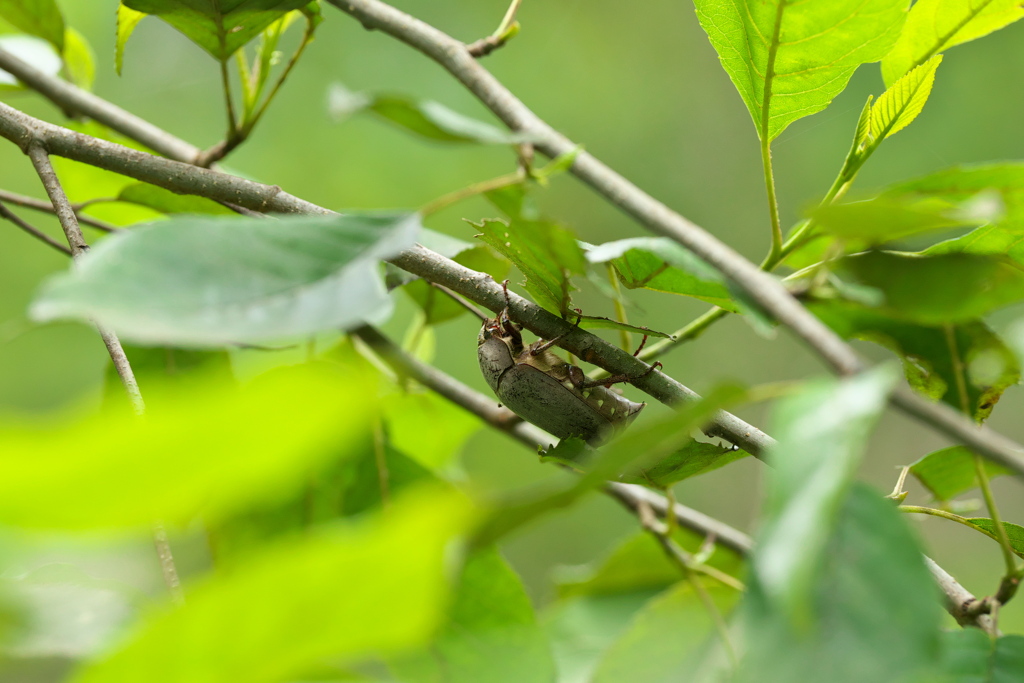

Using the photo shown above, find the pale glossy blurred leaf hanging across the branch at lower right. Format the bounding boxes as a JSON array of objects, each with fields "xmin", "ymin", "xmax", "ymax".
[{"xmin": 755, "ymin": 366, "xmax": 896, "ymax": 623}]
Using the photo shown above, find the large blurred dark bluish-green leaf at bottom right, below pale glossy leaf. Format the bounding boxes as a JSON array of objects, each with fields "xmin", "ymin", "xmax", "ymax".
[{"xmin": 736, "ymin": 483, "xmax": 941, "ymax": 683}]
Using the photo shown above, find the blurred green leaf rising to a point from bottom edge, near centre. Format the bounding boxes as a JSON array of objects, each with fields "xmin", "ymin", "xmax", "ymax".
[{"xmin": 392, "ymin": 548, "xmax": 556, "ymax": 683}]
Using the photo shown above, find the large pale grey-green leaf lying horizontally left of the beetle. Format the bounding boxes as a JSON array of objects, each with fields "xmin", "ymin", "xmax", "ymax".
[{"xmin": 32, "ymin": 213, "xmax": 419, "ymax": 346}]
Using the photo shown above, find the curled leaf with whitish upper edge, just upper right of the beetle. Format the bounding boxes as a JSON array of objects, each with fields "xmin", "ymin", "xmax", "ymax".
[{"xmin": 587, "ymin": 238, "xmax": 739, "ymax": 312}]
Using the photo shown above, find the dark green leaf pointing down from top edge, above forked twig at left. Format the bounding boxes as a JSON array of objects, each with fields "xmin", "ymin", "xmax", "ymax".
[{"xmin": 118, "ymin": 0, "xmax": 309, "ymax": 61}]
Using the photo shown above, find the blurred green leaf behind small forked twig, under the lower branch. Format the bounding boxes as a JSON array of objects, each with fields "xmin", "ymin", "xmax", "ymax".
[{"xmin": 557, "ymin": 527, "xmax": 743, "ymax": 599}]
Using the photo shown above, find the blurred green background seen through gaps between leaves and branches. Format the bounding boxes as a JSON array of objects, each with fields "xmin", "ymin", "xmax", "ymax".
[{"xmin": 0, "ymin": 0, "xmax": 1024, "ymax": 671}]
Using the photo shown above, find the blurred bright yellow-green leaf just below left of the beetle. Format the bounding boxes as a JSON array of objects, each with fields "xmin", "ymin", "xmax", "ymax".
[{"xmin": 383, "ymin": 391, "xmax": 483, "ymax": 471}]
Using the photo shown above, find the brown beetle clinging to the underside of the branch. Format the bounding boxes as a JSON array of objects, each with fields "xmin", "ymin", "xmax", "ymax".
[{"xmin": 476, "ymin": 281, "xmax": 662, "ymax": 445}]
